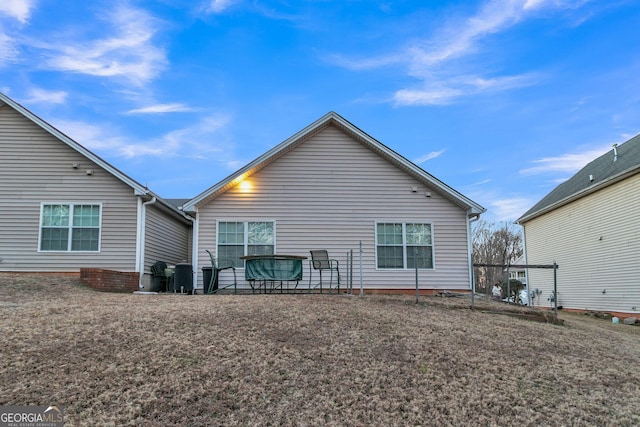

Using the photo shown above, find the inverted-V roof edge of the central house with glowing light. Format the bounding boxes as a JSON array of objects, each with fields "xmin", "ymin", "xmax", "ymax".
[{"xmin": 182, "ymin": 111, "xmax": 486, "ymax": 216}]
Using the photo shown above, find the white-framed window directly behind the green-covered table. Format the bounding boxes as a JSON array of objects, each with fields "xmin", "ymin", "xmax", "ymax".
[{"xmin": 217, "ymin": 221, "xmax": 275, "ymax": 267}]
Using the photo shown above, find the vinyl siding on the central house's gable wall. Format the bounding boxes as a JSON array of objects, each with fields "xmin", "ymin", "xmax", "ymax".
[{"xmin": 198, "ymin": 126, "xmax": 469, "ymax": 289}]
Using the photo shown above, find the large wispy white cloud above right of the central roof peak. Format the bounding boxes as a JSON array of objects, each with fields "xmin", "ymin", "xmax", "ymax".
[{"xmin": 328, "ymin": 0, "xmax": 586, "ymax": 106}]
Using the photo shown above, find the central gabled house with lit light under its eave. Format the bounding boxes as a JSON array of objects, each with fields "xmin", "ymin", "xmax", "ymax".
[{"xmin": 183, "ymin": 112, "xmax": 485, "ymax": 292}]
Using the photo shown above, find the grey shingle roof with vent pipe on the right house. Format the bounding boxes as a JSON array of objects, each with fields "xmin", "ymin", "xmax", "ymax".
[{"xmin": 517, "ymin": 135, "xmax": 640, "ymax": 224}]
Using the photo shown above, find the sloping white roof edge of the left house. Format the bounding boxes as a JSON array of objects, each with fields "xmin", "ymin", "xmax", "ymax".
[{"xmin": 0, "ymin": 92, "xmax": 185, "ymax": 222}]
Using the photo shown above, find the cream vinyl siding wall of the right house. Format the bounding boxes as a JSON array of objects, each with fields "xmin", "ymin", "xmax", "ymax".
[{"xmin": 524, "ymin": 175, "xmax": 640, "ymax": 313}]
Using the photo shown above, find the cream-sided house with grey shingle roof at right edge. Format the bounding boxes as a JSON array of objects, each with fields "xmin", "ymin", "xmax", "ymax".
[{"xmin": 518, "ymin": 135, "xmax": 640, "ymax": 314}]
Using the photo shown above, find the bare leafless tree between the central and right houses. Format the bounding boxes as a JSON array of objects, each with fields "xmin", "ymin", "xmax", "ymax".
[{"xmin": 473, "ymin": 220, "xmax": 522, "ymax": 294}]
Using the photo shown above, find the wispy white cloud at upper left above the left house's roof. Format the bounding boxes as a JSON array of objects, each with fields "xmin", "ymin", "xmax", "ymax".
[{"xmin": 45, "ymin": 6, "xmax": 168, "ymax": 85}]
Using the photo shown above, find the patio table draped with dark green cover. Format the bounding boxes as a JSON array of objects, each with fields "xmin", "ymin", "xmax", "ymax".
[{"xmin": 240, "ymin": 254, "xmax": 307, "ymax": 293}]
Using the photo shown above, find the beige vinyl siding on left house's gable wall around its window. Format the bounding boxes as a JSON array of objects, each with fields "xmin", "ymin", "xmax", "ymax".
[{"xmin": 0, "ymin": 105, "xmax": 137, "ymax": 272}]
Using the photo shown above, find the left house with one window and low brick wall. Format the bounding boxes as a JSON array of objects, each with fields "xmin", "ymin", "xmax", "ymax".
[{"xmin": 0, "ymin": 94, "xmax": 192, "ymax": 287}]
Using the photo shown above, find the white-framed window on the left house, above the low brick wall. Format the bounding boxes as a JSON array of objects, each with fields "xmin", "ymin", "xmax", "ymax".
[{"xmin": 40, "ymin": 203, "xmax": 101, "ymax": 252}]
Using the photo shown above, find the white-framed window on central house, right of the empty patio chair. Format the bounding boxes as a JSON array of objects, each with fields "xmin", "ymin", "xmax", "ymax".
[{"xmin": 376, "ymin": 222, "xmax": 433, "ymax": 269}]
